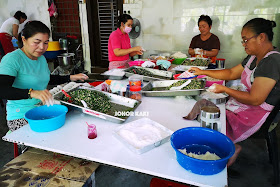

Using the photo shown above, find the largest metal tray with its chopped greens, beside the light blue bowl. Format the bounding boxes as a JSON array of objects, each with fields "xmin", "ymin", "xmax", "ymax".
[{"xmin": 54, "ymin": 86, "xmax": 141, "ymax": 123}]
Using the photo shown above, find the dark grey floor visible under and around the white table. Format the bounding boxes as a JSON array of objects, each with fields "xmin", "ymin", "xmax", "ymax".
[{"xmin": 0, "ymin": 104, "xmax": 280, "ymax": 187}]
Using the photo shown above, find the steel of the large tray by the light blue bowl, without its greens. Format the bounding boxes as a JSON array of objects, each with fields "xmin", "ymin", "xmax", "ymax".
[{"xmin": 54, "ymin": 86, "xmax": 141, "ymax": 123}]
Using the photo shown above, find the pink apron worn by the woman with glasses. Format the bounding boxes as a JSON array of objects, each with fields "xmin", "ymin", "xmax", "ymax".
[{"xmin": 226, "ymin": 51, "xmax": 279, "ymax": 143}]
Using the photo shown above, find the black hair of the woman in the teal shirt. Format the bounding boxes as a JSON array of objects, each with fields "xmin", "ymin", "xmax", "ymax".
[{"xmin": 18, "ymin": 21, "xmax": 50, "ymax": 48}]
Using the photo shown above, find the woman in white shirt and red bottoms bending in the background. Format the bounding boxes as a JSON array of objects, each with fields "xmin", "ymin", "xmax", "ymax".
[{"xmin": 0, "ymin": 11, "xmax": 27, "ymax": 56}]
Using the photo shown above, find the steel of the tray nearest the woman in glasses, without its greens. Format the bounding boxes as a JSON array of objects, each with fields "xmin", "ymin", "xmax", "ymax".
[{"xmin": 142, "ymin": 79, "xmax": 206, "ymax": 97}]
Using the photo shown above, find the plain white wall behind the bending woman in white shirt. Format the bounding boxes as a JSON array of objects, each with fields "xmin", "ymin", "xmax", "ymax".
[{"xmin": 0, "ymin": 0, "xmax": 51, "ymax": 36}]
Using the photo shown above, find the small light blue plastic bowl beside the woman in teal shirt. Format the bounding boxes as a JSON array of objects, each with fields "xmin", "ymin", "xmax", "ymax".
[{"xmin": 25, "ymin": 105, "xmax": 68, "ymax": 132}]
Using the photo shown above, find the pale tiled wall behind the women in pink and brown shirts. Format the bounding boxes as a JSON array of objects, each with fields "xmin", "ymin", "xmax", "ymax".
[{"xmin": 123, "ymin": 0, "xmax": 280, "ymax": 68}]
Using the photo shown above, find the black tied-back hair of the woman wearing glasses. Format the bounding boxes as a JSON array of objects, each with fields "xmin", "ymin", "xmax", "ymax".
[{"xmin": 243, "ymin": 18, "xmax": 276, "ymax": 41}]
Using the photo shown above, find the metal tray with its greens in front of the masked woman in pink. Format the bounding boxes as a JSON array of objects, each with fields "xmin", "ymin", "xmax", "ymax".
[{"xmin": 124, "ymin": 66, "xmax": 173, "ymax": 81}]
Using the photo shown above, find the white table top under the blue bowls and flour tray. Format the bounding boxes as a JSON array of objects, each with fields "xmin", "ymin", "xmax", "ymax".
[{"xmin": 3, "ymin": 96, "xmax": 227, "ymax": 187}]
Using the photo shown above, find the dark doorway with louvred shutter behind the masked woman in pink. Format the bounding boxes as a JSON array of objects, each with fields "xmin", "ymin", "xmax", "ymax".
[{"xmin": 86, "ymin": 0, "xmax": 123, "ymax": 68}]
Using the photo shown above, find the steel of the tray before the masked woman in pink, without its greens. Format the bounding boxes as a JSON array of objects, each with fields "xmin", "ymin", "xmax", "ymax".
[{"xmin": 125, "ymin": 66, "xmax": 173, "ymax": 81}]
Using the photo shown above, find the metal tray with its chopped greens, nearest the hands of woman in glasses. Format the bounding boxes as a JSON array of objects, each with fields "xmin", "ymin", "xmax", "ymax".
[{"xmin": 142, "ymin": 78, "xmax": 206, "ymax": 97}]
